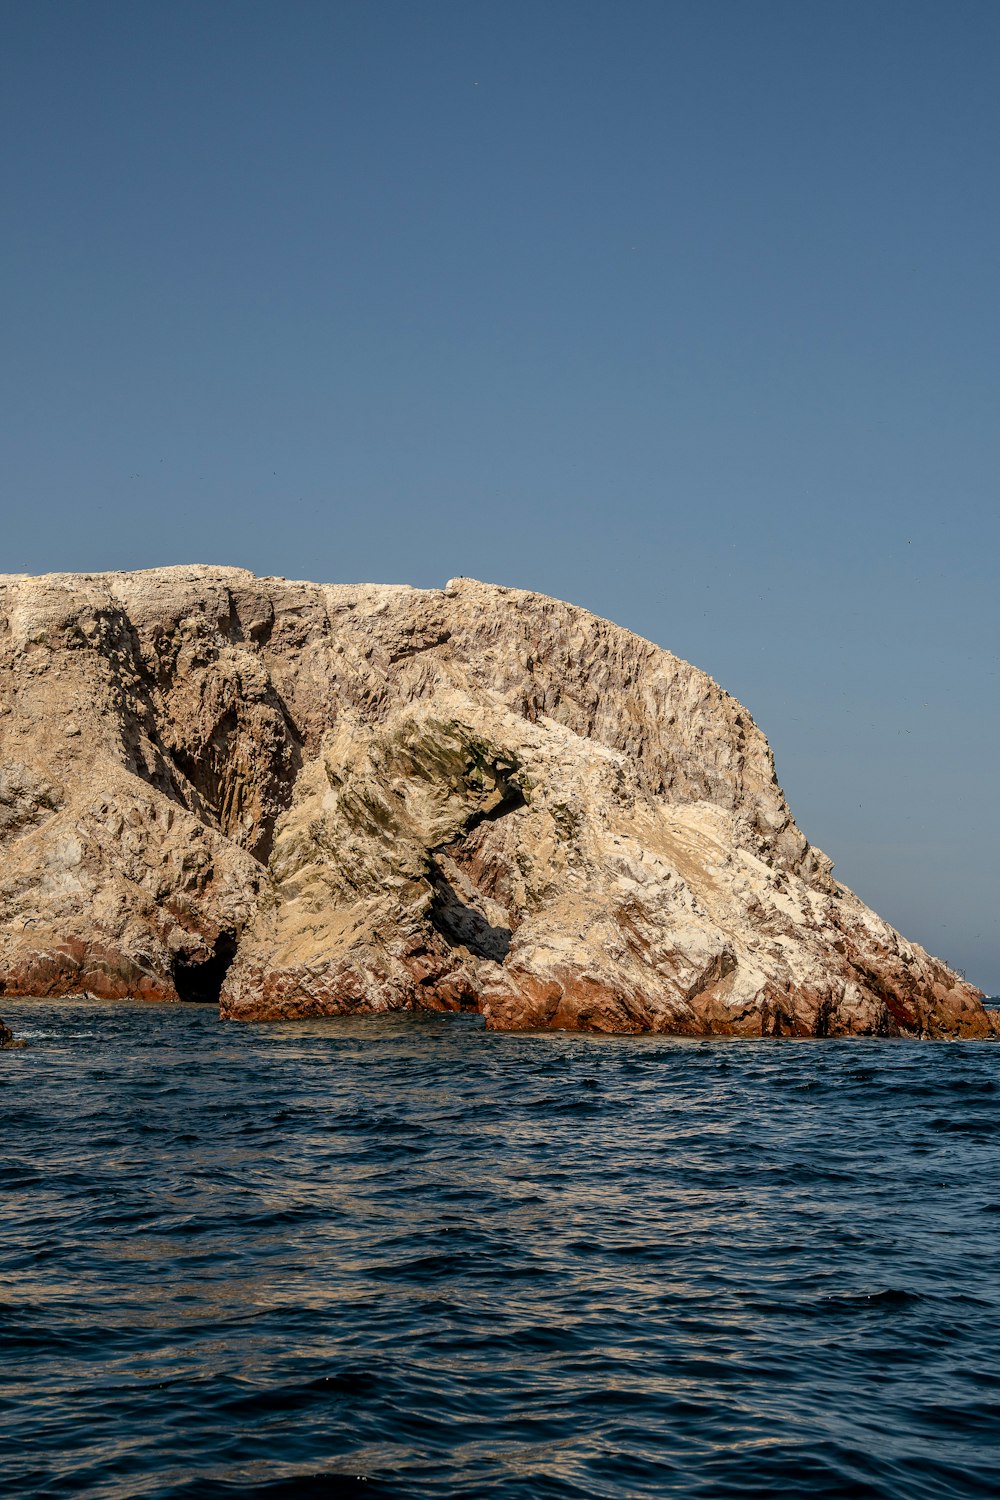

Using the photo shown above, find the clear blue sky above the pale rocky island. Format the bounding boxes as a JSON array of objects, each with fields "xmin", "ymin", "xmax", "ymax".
[{"xmin": 0, "ymin": 0, "xmax": 1000, "ymax": 993}]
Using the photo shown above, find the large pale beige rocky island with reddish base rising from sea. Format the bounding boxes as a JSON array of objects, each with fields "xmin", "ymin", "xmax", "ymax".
[{"xmin": 0, "ymin": 567, "xmax": 996, "ymax": 1037}]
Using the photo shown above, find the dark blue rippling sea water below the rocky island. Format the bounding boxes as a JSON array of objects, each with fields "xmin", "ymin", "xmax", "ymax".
[{"xmin": 0, "ymin": 1001, "xmax": 1000, "ymax": 1500}]
